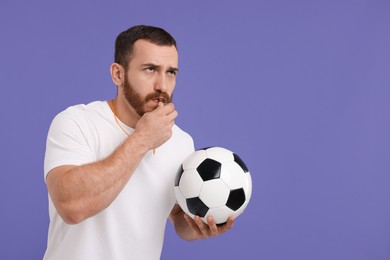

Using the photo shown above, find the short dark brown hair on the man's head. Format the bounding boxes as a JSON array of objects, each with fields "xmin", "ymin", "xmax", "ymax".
[{"xmin": 114, "ymin": 25, "xmax": 177, "ymax": 70}]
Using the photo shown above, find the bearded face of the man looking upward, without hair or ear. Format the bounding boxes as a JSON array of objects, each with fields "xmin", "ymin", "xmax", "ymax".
[{"xmin": 123, "ymin": 40, "xmax": 178, "ymax": 116}]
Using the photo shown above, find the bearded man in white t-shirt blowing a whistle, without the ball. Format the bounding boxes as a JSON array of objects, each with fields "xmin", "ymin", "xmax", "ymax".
[{"xmin": 44, "ymin": 26, "xmax": 233, "ymax": 260}]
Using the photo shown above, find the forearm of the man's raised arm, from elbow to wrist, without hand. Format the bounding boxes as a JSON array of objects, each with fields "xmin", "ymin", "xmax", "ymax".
[{"xmin": 47, "ymin": 135, "xmax": 147, "ymax": 224}]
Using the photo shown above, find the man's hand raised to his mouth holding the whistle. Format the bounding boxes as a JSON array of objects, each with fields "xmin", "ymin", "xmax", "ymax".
[{"xmin": 134, "ymin": 102, "xmax": 178, "ymax": 150}]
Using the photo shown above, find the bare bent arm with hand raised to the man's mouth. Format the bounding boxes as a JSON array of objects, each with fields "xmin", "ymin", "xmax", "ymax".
[{"xmin": 46, "ymin": 104, "xmax": 177, "ymax": 224}]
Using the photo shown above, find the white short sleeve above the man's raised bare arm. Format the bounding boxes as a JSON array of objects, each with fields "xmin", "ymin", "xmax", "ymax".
[{"xmin": 44, "ymin": 110, "xmax": 95, "ymax": 179}]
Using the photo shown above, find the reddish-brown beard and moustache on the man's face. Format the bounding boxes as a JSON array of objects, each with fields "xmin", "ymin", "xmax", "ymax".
[{"xmin": 123, "ymin": 73, "xmax": 172, "ymax": 116}]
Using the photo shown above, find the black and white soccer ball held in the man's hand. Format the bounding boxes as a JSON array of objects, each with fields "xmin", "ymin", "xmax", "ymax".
[{"xmin": 174, "ymin": 147, "xmax": 252, "ymax": 224}]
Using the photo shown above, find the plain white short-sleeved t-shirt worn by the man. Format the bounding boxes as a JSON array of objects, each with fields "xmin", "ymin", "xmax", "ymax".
[{"xmin": 44, "ymin": 101, "xmax": 194, "ymax": 260}]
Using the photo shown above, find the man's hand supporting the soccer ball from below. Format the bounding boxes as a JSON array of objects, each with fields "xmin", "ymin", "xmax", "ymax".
[{"xmin": 169, "ymin": 204, "xmax": 234, "ymax": 240}]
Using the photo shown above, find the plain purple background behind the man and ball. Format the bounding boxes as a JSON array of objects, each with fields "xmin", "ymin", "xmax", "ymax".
[{"xmin": 0, "ymin": 0, "xmax": 390, "ymax": 260}]
